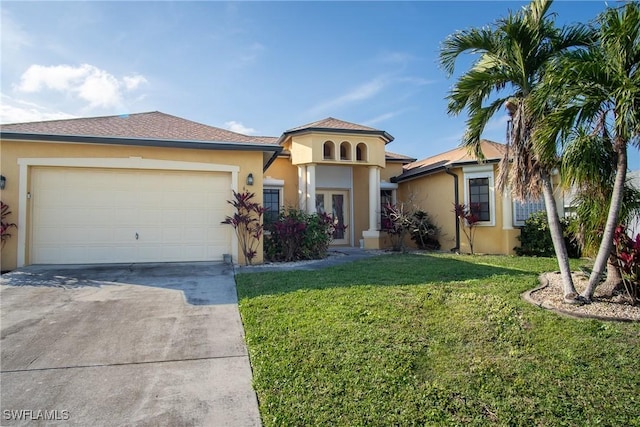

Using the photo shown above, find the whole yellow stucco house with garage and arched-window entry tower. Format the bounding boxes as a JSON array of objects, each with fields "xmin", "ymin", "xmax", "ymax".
[{"xmin": 0, "ymin": 112, "xmax": 562, "ymax": 270}]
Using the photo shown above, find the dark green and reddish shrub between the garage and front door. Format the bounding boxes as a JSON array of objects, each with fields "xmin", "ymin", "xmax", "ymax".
[{"xmin": 264, "ymin": 208, "xmax": 336, "ymax": 261}]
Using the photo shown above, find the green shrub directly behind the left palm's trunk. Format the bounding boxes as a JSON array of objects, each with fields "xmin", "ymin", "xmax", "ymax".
[{"xmin": 513, "ymin": 211, "xmax": 581, "ymax": 258}]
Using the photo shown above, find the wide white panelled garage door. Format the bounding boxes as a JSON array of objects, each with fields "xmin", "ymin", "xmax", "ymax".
[{"xmin": 31, "ymin": 167, "xmax": 233, "ymax": 264}]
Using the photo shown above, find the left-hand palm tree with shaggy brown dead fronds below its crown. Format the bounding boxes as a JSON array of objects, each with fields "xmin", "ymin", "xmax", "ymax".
[{"xmin": 440, "ymin": 0, "xmax": 592, "ymax": 302}]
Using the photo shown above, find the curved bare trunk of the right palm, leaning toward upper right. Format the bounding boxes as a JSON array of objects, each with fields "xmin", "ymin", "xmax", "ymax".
[{"xmin": 582, "ymin": 144, "xmax": 627, "ymax": 300}]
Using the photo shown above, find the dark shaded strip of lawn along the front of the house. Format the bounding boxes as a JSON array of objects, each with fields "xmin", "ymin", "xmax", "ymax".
[{"xmin": 236, "ymin": 254, "xmax": 539, "ymax": 298}]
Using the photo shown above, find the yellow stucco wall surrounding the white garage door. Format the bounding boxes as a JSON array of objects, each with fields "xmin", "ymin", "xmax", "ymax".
[{"xmin": 0, "ymin": 140, "xmax": 263, "ymax": 270}]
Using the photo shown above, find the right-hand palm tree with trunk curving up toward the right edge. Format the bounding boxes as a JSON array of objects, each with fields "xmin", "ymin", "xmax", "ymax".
[{"xmin": 535, "ymin": 2, "xmax": 640, "ymax": 300}]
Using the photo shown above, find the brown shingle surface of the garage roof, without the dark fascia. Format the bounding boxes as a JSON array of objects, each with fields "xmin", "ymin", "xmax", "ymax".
[{"xmin": 0, "ymin": 111, "xmax": 278, "ymax": 145}]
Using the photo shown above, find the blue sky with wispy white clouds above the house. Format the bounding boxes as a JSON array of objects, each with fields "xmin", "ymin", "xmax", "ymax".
[{"xmin": 0, "ymin": 1, "xmax": 640, "ymax": 170}]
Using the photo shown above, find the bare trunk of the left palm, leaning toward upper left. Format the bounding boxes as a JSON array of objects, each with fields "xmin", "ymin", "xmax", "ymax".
[{"xmin": 541, "ymin": 173, "xmax": 578, "ymax": 303}]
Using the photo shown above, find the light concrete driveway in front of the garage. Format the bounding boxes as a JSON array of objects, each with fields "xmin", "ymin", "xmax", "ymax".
[{"xmin": 0, "ymin": 263, "xmax": 260, "ymax": 426}]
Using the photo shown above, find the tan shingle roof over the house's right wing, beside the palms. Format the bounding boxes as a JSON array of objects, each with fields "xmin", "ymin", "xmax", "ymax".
[{"xmin": 394, "ymin": 139, "xmax": 507, "ymax": 182}]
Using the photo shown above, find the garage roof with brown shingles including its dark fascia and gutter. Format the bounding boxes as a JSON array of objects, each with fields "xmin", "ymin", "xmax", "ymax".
[{"xmin": 0, "ymin": 111, "xmax": 282, "ymax": 168}]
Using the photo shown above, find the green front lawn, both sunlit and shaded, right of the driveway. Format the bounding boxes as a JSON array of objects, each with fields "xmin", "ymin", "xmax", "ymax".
[{"xmin": 236, "ymin": 255, "xmax": 640, "ymax": 426}]
